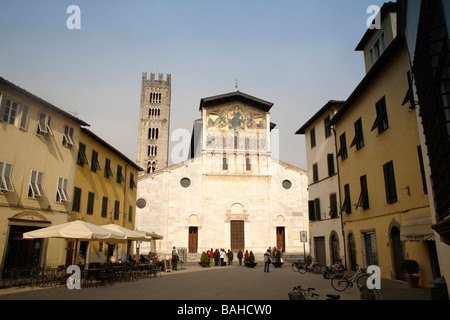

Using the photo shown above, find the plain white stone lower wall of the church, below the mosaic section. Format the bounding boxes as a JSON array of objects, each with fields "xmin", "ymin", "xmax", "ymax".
[{"xmin": 136, "ymin": 158, "xmax": 308, "ymax": 254}]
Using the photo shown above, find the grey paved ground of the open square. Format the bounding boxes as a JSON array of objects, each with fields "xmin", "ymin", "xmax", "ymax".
[{"xmin": 0, "ymin": 262, "xmax": 431, "ymax": 301}]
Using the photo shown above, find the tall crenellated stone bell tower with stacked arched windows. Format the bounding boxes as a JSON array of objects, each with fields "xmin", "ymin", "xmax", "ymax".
[{"xmin": 137, "ymin": 72, "xmax": 171, "ymax": 173}]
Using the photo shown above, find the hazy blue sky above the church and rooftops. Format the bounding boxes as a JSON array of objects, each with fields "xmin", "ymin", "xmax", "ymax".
[{"xmin": 0, "ymin": 0, "xmax": 384, "ymax": 169}]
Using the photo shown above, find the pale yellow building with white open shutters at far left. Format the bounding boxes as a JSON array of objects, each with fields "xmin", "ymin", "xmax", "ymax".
[{"xmin": 0, "ymin": 78, "xmax": 88, "ymax": 276}]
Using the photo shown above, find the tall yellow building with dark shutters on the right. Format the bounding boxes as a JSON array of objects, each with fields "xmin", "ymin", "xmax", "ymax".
[{"xmin": 330, "ymin": 3, "xmax": 439, "ymax": 287}]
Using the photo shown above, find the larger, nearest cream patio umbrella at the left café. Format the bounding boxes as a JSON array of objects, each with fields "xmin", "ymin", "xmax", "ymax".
[{"xmin": 23, "ymin": 220, "xmax": 127, "ymax": 265}]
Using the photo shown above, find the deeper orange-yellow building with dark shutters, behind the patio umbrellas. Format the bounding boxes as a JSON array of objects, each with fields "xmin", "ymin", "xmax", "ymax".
[{"xmin": 71, "ymin": 128, "xmax": 142, "ymax": 263}]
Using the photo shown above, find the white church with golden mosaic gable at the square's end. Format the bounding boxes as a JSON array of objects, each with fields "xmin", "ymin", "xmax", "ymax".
[{"xmin": 136, "ymin": 91, "xmax": 308, "ymax": 255}]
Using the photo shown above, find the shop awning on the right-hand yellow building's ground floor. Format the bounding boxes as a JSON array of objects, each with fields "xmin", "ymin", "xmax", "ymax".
[{"xmin": 400, "ymin": 212, "xmax": 434, "ymax": 241}]
